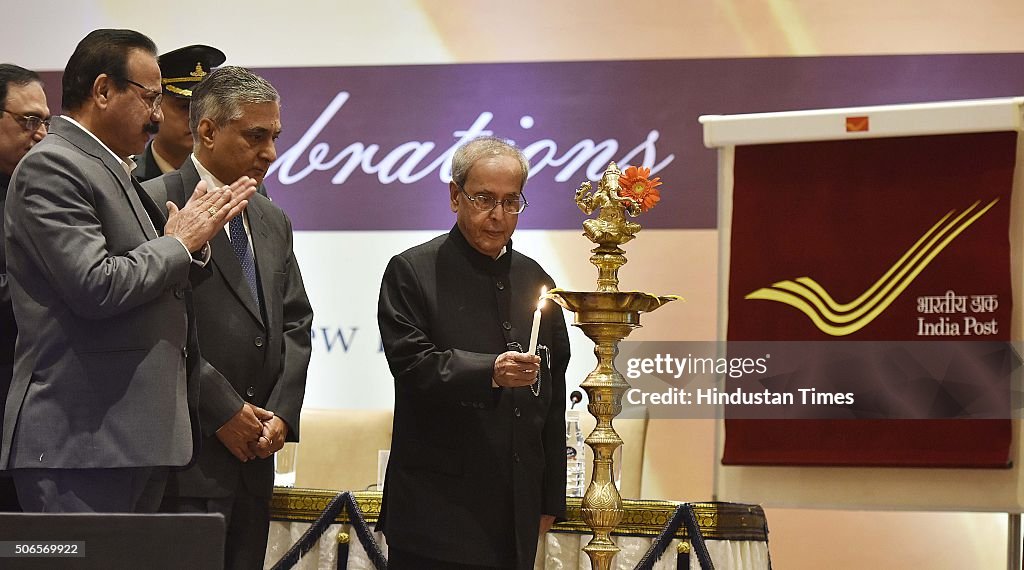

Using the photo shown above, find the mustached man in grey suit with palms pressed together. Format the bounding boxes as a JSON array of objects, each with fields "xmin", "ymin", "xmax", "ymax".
[{"xmin": 0, "ymin": 30, "xmax": 255, "ymax": 512}]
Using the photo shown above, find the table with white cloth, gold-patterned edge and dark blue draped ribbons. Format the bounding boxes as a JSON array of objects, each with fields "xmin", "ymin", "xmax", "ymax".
[{"xmin": 265, "ymin": 487, "xmax": 771, "ymax": 570}]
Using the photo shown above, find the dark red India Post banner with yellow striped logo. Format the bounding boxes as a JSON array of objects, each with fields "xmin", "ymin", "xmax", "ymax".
[{"xmin": 723, "ymin": 132, "xmax": 1018, "ymax": 467}]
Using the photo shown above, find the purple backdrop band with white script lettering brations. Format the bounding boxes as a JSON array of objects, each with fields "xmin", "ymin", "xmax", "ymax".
[{"xmin": 36, "ymin": 53, "xmax": 1024, "ymax": 230}]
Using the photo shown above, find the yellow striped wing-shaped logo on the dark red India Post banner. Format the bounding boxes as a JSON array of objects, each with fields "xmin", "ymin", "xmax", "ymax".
[{"xmin": 744, "ymin": 199, "xmax": 999, "ymax": 337}]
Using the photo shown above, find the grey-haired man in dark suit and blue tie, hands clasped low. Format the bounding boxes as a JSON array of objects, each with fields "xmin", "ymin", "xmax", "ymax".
[{"xmin": 144, "ymin": 67, "xmax": 312, "ymax": 568}]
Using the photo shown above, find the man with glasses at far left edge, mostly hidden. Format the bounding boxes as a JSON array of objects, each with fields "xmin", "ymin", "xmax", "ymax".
[{"xmin": 0, "ymin": 63, "xmax": 50, "ymax": 512}]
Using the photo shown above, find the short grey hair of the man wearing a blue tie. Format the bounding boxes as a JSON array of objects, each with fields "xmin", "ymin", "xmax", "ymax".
[{"xmin": 188, "ymin": 65, "xmax": 281, "ymax": 141}]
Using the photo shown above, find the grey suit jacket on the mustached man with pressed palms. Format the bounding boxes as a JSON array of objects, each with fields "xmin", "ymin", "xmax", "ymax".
[{"xmin": 0, "ymin": 118, "xmax": 196, "ymax": 469}]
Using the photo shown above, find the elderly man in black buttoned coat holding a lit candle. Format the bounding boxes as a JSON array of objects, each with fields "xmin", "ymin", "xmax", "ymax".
[{"xmin": 377, "ymin": 137, "xmax": 569, "ymax": 570}]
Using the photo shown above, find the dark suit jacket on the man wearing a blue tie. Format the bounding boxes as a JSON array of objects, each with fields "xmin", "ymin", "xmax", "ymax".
[{"xmin": 143, "ymin": 159, "xmax": 312, "ymax": 497}]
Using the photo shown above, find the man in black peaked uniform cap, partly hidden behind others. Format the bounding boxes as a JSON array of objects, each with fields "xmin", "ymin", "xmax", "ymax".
[{"xmin": 132, "ymin": 45, "xmax": 227, "ymax": 182}]
